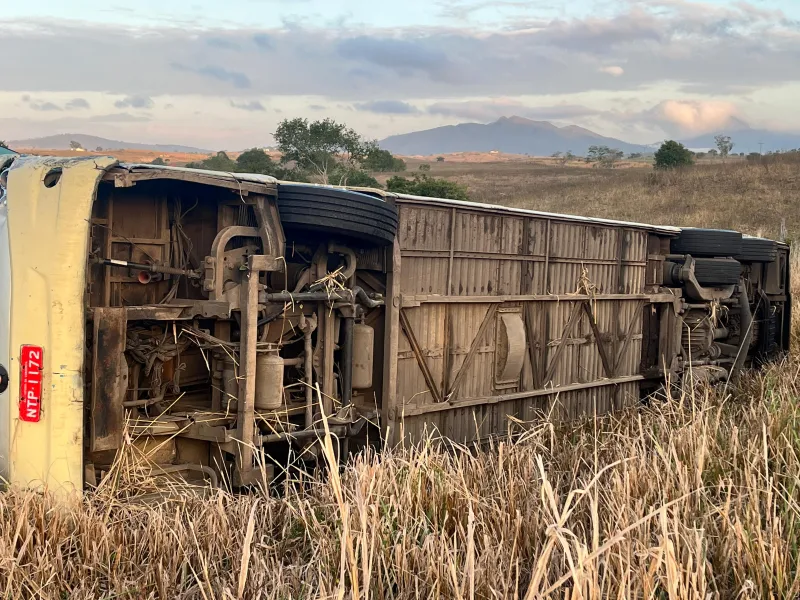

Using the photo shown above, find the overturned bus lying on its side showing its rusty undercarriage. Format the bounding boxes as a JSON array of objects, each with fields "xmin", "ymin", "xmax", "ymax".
[{"xmin": 0, "ymin": 156, "xmax": 791, "ymax": 489}]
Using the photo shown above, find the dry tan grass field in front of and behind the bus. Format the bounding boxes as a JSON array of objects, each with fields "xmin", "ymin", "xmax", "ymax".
[{"xmin": 0, "ymin": 157, "xmax": 800, "ymax": 600}]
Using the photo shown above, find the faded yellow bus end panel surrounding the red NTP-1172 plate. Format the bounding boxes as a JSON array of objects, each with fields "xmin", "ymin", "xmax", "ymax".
[{"xmin": 0, "ymin": 157, "xmax": 116, "ymax": 492}]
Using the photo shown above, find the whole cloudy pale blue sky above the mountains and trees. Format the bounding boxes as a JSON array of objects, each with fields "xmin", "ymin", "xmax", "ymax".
[{"xmin": 0, "ymin": 0, "xmax": 800, "ymax": 150}]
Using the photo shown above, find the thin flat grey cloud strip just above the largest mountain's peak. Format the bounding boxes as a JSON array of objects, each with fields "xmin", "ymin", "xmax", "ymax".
[{"xmin": 427, "ymin": 99, "xmax": 601, "ymax": 122}]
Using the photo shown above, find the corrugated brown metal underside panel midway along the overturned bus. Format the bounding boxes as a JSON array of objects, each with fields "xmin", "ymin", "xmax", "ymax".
[{"xmin": 398, "ymin": 202, "xmax": 647, "ymax": 442}]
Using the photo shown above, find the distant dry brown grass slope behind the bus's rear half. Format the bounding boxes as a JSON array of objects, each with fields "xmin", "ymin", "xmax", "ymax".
[{"xmin": 416, "ymin": 160, "xmax": 800, "ymax": 236}]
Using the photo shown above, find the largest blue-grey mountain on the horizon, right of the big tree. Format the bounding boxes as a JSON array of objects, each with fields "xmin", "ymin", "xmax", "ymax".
[{"xmin": 380, "ymin": 117, "xmax": 645, "ymax": 156}]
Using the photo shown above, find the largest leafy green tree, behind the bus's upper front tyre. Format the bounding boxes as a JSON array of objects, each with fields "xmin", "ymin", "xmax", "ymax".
[{"xmin": 274, "ymin": 118, "xmax": 377, "ymax": 184}]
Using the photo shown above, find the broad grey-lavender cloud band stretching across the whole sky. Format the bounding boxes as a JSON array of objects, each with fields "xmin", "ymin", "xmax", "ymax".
[{"xmin": 0, "ymin": 0, "xmax": 800, "ymax": 108}]
